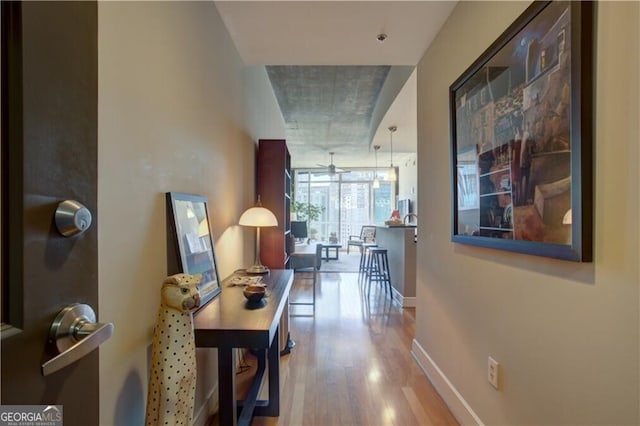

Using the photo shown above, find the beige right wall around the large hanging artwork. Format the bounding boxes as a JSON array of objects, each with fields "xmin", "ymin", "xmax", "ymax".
[{"xmin": 414, "ymin": 2, "xmax": 640, "ymax": 425}]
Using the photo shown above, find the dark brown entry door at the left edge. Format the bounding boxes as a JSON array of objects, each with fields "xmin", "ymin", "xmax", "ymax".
[{"xmin": 1, "ymin": 1, "xmax": 100, "ymax": 425}]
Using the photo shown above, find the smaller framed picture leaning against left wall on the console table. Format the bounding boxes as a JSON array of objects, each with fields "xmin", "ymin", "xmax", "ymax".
[{"xmin": 166, "ymin": 192, "xmax": 221, "ymax": 307}]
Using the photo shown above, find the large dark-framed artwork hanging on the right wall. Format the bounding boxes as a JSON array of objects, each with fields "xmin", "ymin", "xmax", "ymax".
[{"xmin": 449, "ymin": 1, "xmax": 594, "ymax": 262}]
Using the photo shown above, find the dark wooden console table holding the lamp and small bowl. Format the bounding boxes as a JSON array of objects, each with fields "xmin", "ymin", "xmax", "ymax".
[{"xmin": 193, "ymin": 270, "xmax": 293, "ymax": 426}]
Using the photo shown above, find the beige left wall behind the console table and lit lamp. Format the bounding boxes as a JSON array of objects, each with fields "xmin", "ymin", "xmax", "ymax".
[{"xmin": 98, "ymin": 2, "xmax": 284, "ymax": 425}]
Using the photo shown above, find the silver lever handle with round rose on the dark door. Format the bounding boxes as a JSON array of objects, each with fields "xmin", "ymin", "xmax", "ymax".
[{"xmin": 42, "ymin": 303, "xmax": 113, "ymax": 376}]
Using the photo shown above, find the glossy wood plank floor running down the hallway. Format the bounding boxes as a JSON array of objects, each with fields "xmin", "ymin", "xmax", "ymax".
[{"xmin": 213, "ymin": 272, "xmax": 458, "ymax": 426}]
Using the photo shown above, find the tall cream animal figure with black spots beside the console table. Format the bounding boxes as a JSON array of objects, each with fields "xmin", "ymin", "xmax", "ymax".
[{"xmin": 146, "ymin": 274, "xmax": 202, "ymax": 426}]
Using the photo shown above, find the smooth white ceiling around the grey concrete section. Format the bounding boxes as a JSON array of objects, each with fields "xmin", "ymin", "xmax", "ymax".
[{"xmin": 215, "ymin": 1, "xmax": 456, "ymax": 167}]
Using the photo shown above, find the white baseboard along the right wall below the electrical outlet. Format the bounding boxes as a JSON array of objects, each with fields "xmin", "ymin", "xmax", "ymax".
[{"xmin": 411, "ymin": 339, "xmax": 484, "ymax": 426}]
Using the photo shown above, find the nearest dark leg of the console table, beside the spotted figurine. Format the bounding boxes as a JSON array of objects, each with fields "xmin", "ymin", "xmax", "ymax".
[{"xmin": 218, "ymin": 348, "xmax": 238, "ymax": 426}]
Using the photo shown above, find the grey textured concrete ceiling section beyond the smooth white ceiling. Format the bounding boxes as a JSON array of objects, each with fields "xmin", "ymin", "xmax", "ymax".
[{"xmin": 266, "ymin": 66, "xmax": 413, "ymax": 164}]
